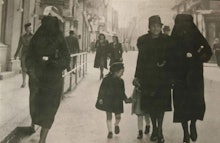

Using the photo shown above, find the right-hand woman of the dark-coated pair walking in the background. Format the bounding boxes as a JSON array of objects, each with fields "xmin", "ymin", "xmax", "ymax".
[{"xmin": 109, "ymin": 36, "xmax": 123, "ymax": 65}]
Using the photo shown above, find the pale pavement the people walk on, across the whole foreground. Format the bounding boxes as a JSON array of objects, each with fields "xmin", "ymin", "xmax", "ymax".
[{"xmin": 0, "ymin": 52, "xmax": 220, "ymax": 143}]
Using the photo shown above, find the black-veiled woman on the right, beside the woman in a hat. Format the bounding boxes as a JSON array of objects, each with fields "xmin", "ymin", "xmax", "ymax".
[{"xmin": 171, "ymin": 14, "xmax": 212, "ymax": 143}]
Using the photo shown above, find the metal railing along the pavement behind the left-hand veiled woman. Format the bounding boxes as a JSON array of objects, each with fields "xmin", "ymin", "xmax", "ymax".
[{"xmin": 63, "ymin": 52, "xmax": 87, "ymax": 94}]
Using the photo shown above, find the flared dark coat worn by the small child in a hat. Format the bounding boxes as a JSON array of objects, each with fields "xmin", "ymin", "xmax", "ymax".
[{"xmin": 96, "ymin": 75, "xmax": 127, "ymax": 114}]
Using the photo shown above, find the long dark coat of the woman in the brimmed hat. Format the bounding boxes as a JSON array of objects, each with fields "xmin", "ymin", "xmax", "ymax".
[{"xmin": 135, "ymin": 34, "xmax": 171, "ymax": 113}]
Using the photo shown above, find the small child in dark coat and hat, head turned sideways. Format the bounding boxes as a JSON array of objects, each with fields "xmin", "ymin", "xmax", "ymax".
[{"xmin": 96, "ymin": 62, "xmax": 130, "ymax": 139}]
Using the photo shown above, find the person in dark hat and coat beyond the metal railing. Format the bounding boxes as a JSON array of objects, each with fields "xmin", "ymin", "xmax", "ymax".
[{"xmin": 65, "ymin": 30, "xmax": 80, "ymax": 73}]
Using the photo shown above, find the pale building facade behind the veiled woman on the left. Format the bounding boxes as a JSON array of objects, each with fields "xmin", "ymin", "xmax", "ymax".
[{"xmin": 0, "ymin": 0, "xmax": 91, "ymax": 74}]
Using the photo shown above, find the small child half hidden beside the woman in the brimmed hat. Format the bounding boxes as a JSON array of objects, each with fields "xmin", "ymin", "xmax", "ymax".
[{"xmin": 131, "ymin": 79, "xmax": 150, "ymax": 139}]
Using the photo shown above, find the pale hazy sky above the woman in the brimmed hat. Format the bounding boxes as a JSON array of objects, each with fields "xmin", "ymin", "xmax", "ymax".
[{"xmin": 110, "ymin": 0, "xmax": 175, "ymax": 27}]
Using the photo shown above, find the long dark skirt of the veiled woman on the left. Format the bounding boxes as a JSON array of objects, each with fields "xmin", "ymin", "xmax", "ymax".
[{"xmin": 29, "ymin": 71, "xmax": 63, "ymax": 129}]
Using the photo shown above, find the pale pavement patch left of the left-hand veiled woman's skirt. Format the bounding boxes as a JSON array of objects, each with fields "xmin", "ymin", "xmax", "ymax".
[{"xmin": 0, "ymin": 74, "xmax": 30, "ymax": 141}]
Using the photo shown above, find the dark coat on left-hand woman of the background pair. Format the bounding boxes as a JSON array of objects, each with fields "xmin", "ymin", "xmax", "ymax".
[{"xmin": 94, "ymin": 40, "xmax": 109, "ymax": 69}]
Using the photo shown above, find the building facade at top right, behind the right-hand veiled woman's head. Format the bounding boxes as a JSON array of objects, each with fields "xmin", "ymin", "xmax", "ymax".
[{"xmin": 173, "ymin": 0, "xmax": 220, "ymax": 48}]
